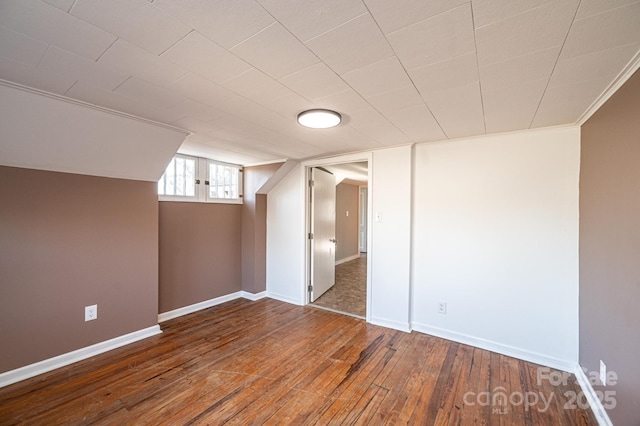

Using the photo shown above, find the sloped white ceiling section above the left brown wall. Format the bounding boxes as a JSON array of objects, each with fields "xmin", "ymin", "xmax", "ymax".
[{"xmin": 0, "ymin": 84, "xmax": 186, "ymax": 181}]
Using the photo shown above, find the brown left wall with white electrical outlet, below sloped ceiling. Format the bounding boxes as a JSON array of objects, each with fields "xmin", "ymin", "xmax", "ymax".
[{"xmin": 0, "ymin": 167, "xmax": 158, "ymax": 372}]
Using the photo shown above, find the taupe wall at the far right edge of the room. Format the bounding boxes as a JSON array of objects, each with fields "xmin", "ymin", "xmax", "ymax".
[{"xmin": 580, "ymin": 68, "xmax": 640, "ymax": 425}]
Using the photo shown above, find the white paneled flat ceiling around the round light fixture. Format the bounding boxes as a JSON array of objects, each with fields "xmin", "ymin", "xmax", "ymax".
[{"xmin": 0, "ymin": 0, "xmax": 640, "ymax": 164}]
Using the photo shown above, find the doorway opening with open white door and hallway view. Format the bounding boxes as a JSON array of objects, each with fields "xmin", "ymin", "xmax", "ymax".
[{"xmin": 307, "ymin": 161, "xmax": 369, "ymax": 319}]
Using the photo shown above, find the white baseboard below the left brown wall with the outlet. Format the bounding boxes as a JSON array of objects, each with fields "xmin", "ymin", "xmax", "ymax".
[{"xmin": 0, "ymin": 325, "xmax": 162, "ymax": 388}]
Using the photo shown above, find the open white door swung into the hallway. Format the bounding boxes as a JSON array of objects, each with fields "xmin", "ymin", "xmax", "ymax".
[{"xmin": 309, "ymin": 167, "xmax": 336, "ymax": 302}]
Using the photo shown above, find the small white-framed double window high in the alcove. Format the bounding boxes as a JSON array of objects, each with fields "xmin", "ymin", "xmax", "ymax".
[{"xmin": 158, "ymin": 154, "xmax": 242, "ymax": 203}]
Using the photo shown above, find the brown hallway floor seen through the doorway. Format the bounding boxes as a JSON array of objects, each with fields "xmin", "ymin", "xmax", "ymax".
[{"xmin": 313, "ymin": 253, "xmax": 367, "ymax": 318}]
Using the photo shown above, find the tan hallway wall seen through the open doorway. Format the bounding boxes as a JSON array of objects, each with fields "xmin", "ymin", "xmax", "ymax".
[{"xmin": 336, "ymin": 183, "xmax": 360, "ymax": 262}]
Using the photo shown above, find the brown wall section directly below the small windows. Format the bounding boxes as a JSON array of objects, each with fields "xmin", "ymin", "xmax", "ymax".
[{"xmin": 159, "ymin": 201, "xmax": 242, "ymax": 313}]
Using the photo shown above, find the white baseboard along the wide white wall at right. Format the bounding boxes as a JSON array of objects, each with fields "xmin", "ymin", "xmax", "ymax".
[{"xmin": 411, "ymin": 322, "xmax": 576, "ymax": 373}]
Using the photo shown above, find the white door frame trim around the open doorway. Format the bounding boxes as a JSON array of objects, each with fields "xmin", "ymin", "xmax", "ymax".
[{"xmin": 302, "ymin": 152, "xmax": 373, "ymax": 322}]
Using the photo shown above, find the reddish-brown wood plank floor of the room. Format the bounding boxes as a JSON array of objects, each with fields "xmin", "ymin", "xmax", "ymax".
[{"xmin": 0, "ymin": 299, "xmax": 596, "ymax": 425}]
